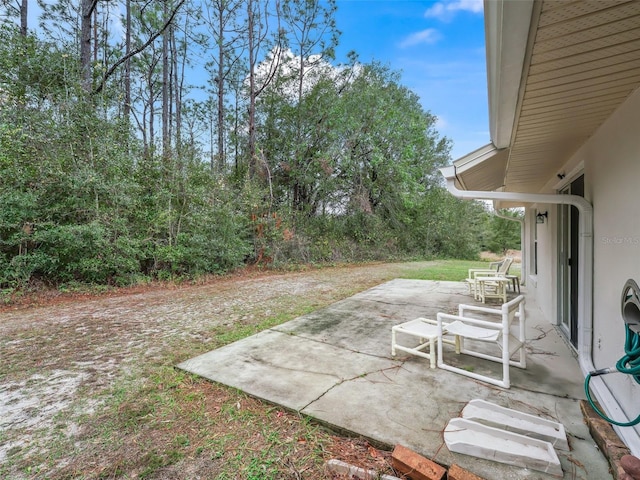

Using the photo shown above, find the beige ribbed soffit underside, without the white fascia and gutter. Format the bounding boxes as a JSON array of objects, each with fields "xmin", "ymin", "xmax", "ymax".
[{"xmin": 504, "ymin": 0, "xmax": 640, "ymax": 192}]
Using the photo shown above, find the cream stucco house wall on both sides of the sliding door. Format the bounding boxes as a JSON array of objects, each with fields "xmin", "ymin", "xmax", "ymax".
[{"xmin": 527, "ymin": 90, "xmax": 640, "ymax": 442}]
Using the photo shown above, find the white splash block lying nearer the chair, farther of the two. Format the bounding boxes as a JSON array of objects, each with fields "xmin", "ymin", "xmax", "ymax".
[{"xmin": 461, "ymin": 399, "xmax": 569, "ymax": 451}]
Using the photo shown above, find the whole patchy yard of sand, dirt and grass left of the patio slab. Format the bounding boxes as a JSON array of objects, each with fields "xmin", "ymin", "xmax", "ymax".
[{"xmin": 0, "ymin": 264, "xmax": 425, "ymax": 479}]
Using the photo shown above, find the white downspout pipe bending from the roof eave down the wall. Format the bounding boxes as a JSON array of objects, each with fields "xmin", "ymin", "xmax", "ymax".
[{"xmin": 440, "ymin": 166, "xmax": 640, "ymax": 455}]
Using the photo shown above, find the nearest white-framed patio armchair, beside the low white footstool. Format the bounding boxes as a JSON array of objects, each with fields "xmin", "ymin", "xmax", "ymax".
[{"xmin": 437, "ymin": 295, "xmax": 527, "ymax": 388}]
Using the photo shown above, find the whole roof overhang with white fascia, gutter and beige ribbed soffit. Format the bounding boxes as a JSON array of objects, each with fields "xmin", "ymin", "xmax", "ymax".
[{"xmin": 454, "ymin": 0, "xmax": 640, "ymax": 193}]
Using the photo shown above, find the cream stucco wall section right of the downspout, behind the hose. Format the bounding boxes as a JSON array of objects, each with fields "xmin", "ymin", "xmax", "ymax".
[{"xmin": 580, "ymin": 90, "xmax": 640, "ymax": 440}]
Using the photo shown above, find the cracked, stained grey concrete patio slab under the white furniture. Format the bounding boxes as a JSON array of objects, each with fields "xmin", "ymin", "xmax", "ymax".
[{"xmin": 178, "ymin": 279, "xmax": 613, "ymax": 480}]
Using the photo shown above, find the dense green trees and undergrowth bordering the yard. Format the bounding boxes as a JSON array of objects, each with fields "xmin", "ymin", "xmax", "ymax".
[{"xmin": 0, "ymin": 1, "xmax": 500, "ymax": 290}]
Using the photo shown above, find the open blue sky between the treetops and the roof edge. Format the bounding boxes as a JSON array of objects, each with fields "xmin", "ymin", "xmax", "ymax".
[{"xmin": 336, "ymin": 0, "xmax": 489, "ymax": 160}]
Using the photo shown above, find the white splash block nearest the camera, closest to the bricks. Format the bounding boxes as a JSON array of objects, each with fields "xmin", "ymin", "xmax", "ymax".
[{"xmin": 444, "ymin": 418, "xmax": 563, "ymax": 478}]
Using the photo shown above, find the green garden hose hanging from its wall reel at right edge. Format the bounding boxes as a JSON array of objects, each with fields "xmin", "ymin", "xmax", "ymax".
[{"xmin": 584, "ymin": 280, "xmax": 640, "ymax": 427}]
